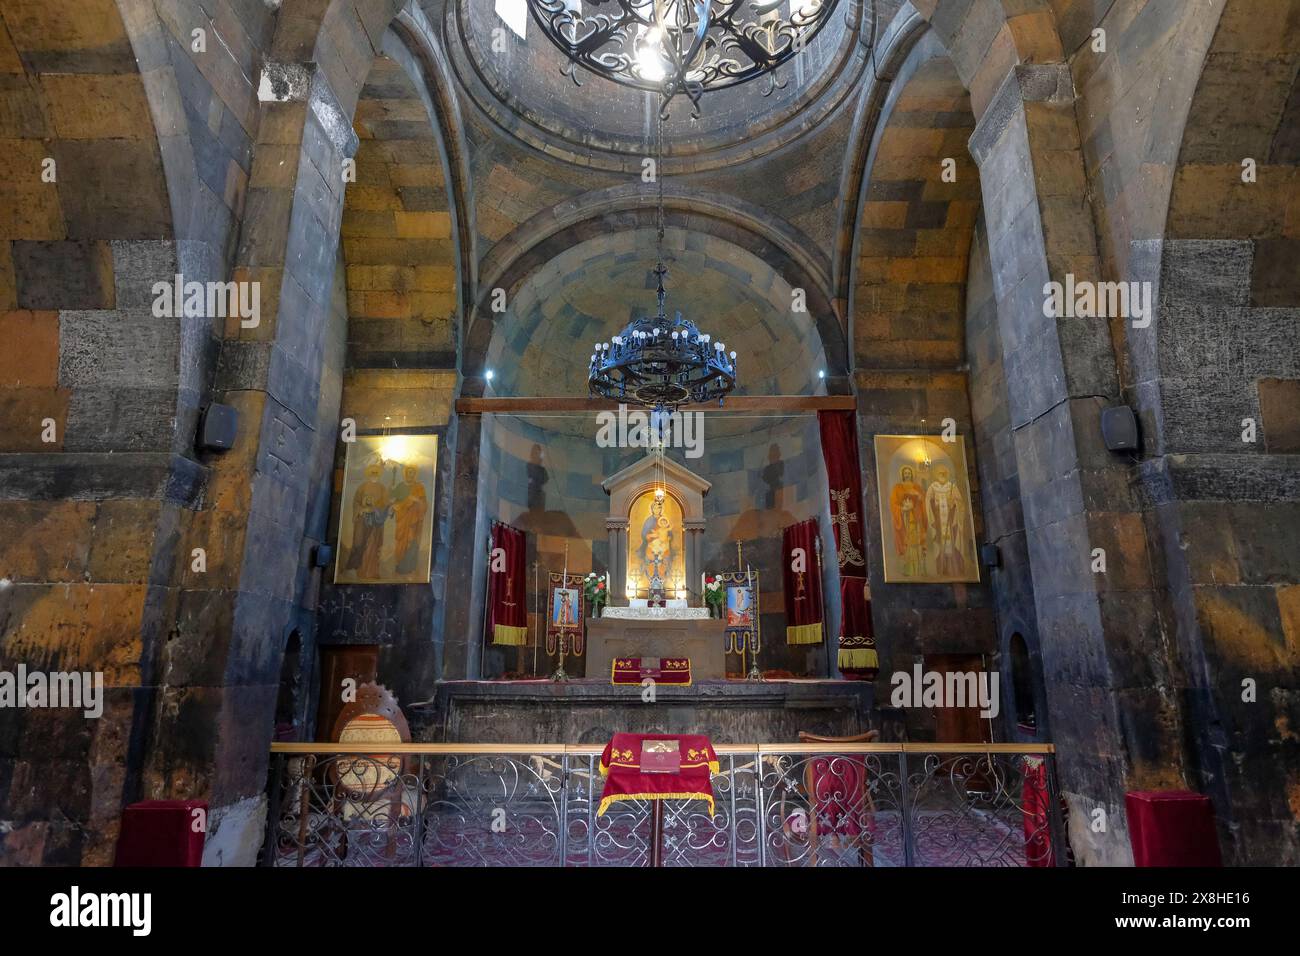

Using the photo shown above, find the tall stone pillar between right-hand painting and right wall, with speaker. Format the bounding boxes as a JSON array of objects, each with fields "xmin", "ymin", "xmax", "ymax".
[{"xmin": 970, "ymin": 64, "xmax": 1182, "ymax": 864}]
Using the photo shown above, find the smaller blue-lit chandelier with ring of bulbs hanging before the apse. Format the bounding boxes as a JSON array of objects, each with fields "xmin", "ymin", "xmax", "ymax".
[{"xmin": 586, "ymin": 120, "xmax": 736, "ymax": 411}]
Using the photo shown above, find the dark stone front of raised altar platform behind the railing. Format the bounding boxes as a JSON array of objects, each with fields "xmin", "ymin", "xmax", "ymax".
[{"xmin": 411, "ymin": 676, "xmax": 875, "ymax": 747}]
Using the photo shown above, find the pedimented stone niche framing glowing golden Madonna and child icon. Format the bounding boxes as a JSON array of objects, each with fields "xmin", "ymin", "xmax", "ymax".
[{"xmin": 601, "ymin": 453, "xmax": 712, "ymax": 607}]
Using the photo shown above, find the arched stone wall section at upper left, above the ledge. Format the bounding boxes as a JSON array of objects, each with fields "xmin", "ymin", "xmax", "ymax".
[{"xmin": 0, "ymin": 0, "xmax": 182, "ymax": 453}]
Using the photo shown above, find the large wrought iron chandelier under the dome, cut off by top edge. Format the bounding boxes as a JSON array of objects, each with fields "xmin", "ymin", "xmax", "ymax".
[{"xmin": 528, "ymin": 0, "xmax": 840, "ymax": 116}]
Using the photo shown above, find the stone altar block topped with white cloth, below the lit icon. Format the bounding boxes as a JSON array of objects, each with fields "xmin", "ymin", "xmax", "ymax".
[{"xmin": 586, "ymin": 600, "xmax": 727, "ymax": 680}]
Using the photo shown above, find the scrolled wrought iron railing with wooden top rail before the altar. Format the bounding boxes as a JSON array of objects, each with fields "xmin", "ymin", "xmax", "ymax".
[{"xmin": 263, "ymin": 744, "xmax": 1067, "ymax": 866}]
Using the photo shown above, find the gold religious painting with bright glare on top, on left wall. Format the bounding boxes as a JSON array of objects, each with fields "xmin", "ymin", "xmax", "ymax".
[{"xmin": 334, "ymin": 434, "xmax": 438, "ymax": 584}]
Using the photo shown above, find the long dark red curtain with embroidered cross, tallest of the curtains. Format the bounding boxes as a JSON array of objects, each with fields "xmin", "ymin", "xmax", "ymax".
[{"xmin": 816, "ymin": 411, "xmax": 880, "ymax": 680}]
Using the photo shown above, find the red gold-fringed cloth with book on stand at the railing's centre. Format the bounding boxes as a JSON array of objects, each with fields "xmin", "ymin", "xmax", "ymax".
[{"xmin": 595, "ymin": 734, "xmax": 719, "ymax": 817}]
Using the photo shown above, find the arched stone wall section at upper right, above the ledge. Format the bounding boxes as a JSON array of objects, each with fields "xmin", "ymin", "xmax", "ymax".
[{"xmin": 1149, "ymin": 0, "xmax": 1300, "ymax": 454}]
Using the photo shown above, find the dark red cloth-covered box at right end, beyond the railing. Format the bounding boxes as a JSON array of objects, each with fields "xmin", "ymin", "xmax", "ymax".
[{"xmin": 1125, "ymin": 790, "xmax": 1223, "ymax": 866}]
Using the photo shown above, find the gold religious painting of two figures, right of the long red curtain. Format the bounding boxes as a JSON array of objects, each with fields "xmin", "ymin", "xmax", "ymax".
[{"xmin": 875, "ymin": 434, "xmax": 979, "ymax": 584}]
